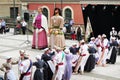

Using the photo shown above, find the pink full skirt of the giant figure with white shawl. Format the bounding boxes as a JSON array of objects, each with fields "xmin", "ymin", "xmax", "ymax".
[{"xmin": 32, "ymin": 30, "xmax": 48, "ymax": 49}]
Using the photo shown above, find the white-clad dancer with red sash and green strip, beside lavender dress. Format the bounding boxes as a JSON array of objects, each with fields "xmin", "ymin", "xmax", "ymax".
[{"xmin": 52, "ymin": 47, "xmax": 65, "ymax": 80}]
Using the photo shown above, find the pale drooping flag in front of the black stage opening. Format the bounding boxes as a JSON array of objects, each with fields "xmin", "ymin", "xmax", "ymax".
[{"xmin": 85, "ymin": 17, "xmax": 93, "ymax": 41}]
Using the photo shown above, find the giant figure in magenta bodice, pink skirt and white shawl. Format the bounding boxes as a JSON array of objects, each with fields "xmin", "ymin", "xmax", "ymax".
[{"xmin": 32, "ymin": 7, "xmax": 48, "ymax": 49}]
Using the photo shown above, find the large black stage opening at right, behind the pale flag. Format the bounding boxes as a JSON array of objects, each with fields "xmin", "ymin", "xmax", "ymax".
[{"xmin": 83, "ymin": 5, "xmax": 120, "ymax": 38}]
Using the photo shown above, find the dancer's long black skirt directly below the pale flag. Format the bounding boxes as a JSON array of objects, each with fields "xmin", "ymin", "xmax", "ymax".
[{"xmin": 84, "ymin": 55, "xmax": 95, "ymax": 72}]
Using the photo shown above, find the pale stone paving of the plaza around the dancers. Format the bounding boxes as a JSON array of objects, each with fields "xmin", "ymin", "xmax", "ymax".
[{"xmin": 0, "ymin": 29, "xmax": 120, "ymax": 80}]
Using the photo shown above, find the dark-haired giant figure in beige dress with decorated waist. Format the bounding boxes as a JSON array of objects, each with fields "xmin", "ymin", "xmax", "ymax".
[{"xmin": 49, "ymin": 8, "xmax": 65, "ymax": 49}]
